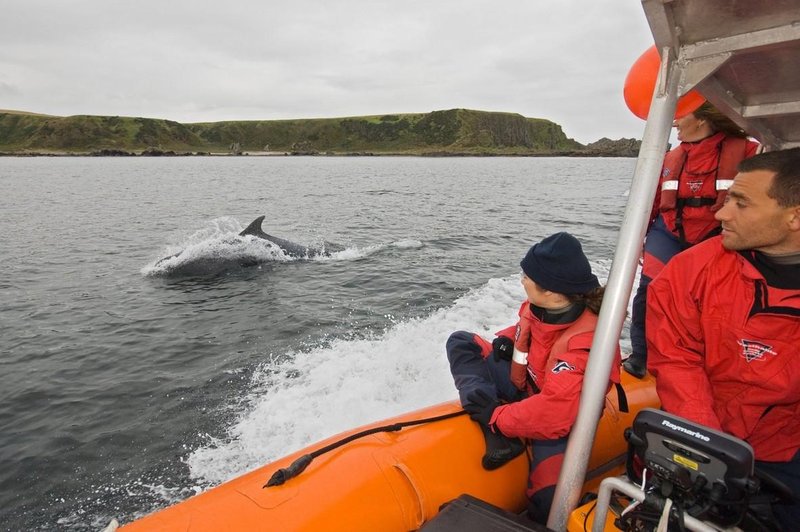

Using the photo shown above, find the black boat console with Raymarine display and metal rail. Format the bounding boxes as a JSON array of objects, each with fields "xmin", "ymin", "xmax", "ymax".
[{"xmin": 593, "ymin": 408, "xmax": 791, "ymax": 531}]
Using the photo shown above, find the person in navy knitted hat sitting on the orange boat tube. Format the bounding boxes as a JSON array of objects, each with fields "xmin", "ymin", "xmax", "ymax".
[{"xmin": 447, "ymin": 232, "xmax": 620, "ymax": 523}]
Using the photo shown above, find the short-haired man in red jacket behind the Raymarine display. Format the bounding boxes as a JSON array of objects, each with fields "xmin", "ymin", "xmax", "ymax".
[{"xmin": 647, "ymin": 148, "xmax": 800, "ymax": 530}]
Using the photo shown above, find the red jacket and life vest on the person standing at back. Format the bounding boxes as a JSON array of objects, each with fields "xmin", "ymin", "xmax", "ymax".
[{"xmin": 651, "ymin": 132, "xmax": 758, "ymax": 244}]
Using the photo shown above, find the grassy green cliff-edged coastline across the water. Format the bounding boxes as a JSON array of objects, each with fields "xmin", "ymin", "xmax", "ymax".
[{"xmin": 0, "ymin": 109, "xmax": 641, "ymax": 157}]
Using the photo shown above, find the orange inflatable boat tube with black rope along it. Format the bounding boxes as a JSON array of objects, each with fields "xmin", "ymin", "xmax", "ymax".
[{"xmin": 120, "ymin": 374, "xmax": 658, "ymax": 532}]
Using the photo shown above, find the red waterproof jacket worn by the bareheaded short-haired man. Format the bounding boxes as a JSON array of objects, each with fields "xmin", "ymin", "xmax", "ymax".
[{"xmin": 647, "ymin": 237, "xmax": 800, "ymax": 461}]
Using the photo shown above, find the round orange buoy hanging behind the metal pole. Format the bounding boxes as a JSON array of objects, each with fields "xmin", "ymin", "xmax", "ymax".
[{"xmin": 623, "ymin": 45, "xmax": 706, "ymax": 120}]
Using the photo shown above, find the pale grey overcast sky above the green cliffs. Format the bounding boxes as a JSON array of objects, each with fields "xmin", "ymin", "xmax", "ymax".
[{"xmin": 0, "ymin": 0, "xmax": 652, "ymax": 144}]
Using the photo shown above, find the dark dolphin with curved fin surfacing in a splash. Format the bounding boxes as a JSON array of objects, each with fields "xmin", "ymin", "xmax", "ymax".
[{"xmin": 154, "ymin": 216, "xmax": 344, "ymax": 277}]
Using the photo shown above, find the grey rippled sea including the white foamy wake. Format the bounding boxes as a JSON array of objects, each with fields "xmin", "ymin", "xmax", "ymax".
[{"xmin": 0, "ymin": 157, "xmax": 635, "ymax": 531}]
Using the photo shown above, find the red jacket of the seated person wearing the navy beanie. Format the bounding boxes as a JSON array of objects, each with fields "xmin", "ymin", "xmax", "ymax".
[{"xmin": 482, "ymin": 302, "xmax": 621, "ymax": 440}]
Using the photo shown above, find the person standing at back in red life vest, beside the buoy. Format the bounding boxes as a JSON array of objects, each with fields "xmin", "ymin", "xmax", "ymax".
[{"xmin": 623, "ymin": 102, "xmax": 758, "ymax": 378}]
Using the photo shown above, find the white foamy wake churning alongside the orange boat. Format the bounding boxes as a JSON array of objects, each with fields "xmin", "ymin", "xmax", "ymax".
[{"xmin": 185, "ymin": 276, "xmax": 523, "ymax": 485}]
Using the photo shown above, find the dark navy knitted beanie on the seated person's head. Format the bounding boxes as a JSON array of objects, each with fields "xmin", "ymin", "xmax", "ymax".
[{"xmin": 520, "ymin": 232, "xmax": 600, "ymax": 294}]
